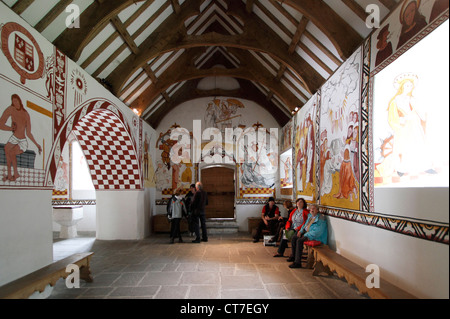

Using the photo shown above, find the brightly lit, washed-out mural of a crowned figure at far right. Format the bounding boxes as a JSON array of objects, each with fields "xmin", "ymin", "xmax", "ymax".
[{"xmin": 373, "ymin": 21, "xmax": 449, "ymax": 187}]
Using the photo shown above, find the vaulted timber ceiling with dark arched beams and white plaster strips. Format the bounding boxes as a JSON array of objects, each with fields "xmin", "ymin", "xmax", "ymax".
[{"xmin": 2, "ymin": 0, "xmax": 400, "ymax": 128}]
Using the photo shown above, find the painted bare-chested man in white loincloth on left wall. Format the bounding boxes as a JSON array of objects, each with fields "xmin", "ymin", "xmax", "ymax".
[{"xmin": 0, "ymin": 94, "xmax": 42, "ymax": 182}]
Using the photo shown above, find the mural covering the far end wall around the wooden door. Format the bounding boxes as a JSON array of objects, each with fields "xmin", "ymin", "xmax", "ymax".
[{"xmin": 153, "ymin": 97, "xmax": 279, "ymax": 199}]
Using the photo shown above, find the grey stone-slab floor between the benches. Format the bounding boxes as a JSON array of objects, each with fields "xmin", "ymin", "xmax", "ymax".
[{"xmin": 50, "ymin": 233, "xmax": 366, "ymax": 299}]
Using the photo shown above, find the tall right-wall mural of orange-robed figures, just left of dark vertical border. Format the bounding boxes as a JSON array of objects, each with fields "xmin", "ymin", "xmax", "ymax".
[{"xmin": 320, "ymin": 48, "xmax": 362, "ymax": 210}]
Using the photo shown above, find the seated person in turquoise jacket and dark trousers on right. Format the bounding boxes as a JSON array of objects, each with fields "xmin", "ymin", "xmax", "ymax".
[{"xmin": 288, "ymin": 204, "xmax": 328, "ymax": 268}]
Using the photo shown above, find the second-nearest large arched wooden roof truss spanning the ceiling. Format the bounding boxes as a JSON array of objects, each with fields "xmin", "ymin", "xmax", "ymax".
[{"xmin": 108, "ymin": 0, "xmax": 325, "ymax": 94}]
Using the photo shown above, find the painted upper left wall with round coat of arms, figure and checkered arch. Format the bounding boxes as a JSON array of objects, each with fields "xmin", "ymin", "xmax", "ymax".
[{"xmin": 0, "ymin": 3, "xmax": 154, "ymax": 192}]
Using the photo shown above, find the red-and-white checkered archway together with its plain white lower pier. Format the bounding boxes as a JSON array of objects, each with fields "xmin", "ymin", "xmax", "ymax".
[{"xmin": 47, "ymin": 100, "xmax": 143, "ymax": 239}]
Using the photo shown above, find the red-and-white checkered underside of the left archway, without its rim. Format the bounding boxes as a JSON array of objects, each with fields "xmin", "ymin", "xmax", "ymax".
[{"xmin": 73, "ymin": 109, "xmax": 141, "ymax": 190}]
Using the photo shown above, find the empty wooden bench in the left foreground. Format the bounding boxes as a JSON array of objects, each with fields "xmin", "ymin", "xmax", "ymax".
[{"xmin": 0, "ymin": 252, "xmax": 94, "ymax": 299}]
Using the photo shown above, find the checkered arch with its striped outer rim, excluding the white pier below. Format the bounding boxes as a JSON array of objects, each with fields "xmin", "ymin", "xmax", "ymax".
[{"xmin": 46, "ymin": 99, "xmax": 142, "ymax": 190}]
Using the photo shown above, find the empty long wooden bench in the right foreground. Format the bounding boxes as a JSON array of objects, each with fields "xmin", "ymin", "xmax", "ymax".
[{"xmin": 312, "ymin": 245, "xmax": 417, "ymax": 299}]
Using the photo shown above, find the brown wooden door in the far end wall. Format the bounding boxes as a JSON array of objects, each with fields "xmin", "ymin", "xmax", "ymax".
[{"xmin": 201, "ymin": 167, "xmax": 235, "ymax": 218}]
